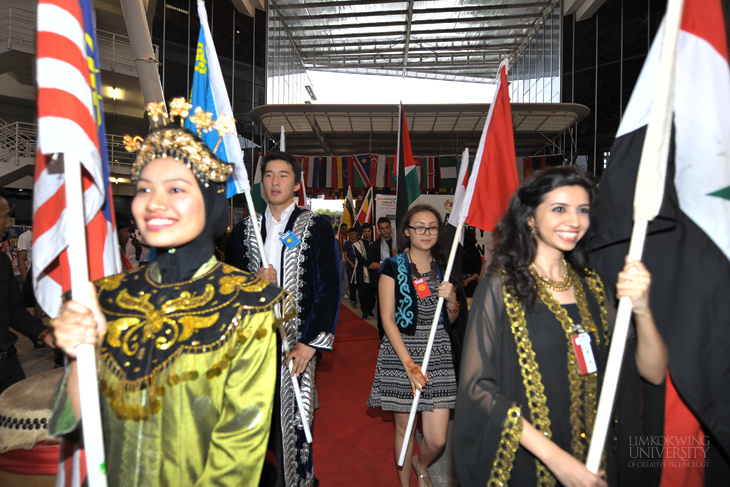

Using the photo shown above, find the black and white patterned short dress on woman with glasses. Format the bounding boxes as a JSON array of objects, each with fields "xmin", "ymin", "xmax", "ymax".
[{"xmin": 367, "ymin": 273, "xmax": 456, "ymax": 413}]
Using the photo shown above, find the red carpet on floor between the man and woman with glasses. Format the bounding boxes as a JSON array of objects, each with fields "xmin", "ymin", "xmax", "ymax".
[{"xmin": 314, "ymin": 306, "xmax": 418, "ymax": 487}]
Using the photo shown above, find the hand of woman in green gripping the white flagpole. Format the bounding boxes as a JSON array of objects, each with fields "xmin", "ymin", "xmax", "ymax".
[{"xmin": 53, "ymin": 283, "xmax": 106, "ymax": 358}]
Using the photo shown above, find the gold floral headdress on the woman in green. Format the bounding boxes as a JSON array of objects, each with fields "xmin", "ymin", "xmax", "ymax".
[{"xmin": 124, "ymin": 98, "xmax": 236, "ymax": 186}]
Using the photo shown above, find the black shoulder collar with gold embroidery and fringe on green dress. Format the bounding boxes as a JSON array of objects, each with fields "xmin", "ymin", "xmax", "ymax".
[{"xmin": 99, "ymin": 264, "xmax": 293, "ymax": 420}]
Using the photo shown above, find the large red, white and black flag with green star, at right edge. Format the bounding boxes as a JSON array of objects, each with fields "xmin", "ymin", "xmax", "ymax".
[{"xmin": 594, "ymin": 0, "xmax": 730, "ymax": 476}]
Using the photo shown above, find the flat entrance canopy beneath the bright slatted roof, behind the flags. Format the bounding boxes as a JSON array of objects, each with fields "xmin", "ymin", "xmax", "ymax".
[{"xmin": 251, "ymin": 103, "xmax": 589, "ymax": 157}]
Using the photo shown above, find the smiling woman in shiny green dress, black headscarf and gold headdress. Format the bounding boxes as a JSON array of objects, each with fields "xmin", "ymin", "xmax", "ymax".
[{"xmin": 51, "ymin": 99, "xmax": 288, "ymax": 487}]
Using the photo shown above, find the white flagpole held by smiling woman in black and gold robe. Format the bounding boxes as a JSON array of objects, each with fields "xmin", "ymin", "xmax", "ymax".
[{"xmin": 586, "ymin": 0, "xmax": 684, "ymax": 473}]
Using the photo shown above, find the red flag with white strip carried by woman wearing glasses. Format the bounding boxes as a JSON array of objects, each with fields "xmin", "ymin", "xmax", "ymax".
[{"xmin": 458, "ymin": 61, "xmax": 520, "ymax": 232}]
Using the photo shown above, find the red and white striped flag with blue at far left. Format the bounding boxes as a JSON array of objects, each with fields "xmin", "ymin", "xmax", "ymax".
[{"xmin": 33, "ymin": 0, "xmax": 121, "ymax": 316}]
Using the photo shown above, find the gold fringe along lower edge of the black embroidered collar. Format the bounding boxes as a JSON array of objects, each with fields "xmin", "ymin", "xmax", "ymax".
[{"xmin": 98, "ymin": 291, "xmax": 294, "ymax": 420}]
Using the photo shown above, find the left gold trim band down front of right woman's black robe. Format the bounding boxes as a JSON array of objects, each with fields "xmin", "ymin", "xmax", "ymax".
[{"xmin": 500, "ymin": 272, "xmax": 556, "ymax": 487}]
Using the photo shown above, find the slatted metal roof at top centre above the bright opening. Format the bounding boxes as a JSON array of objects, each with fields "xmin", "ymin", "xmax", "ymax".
[{"xmin": 270, "ymin": 0, "xmax": 559, "ymax": 82}]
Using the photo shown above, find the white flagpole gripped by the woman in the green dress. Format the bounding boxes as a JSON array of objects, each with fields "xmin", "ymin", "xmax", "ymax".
[{"xmin": 64, "ymin": 154, "xmax": 107, "ymax": 487}]
